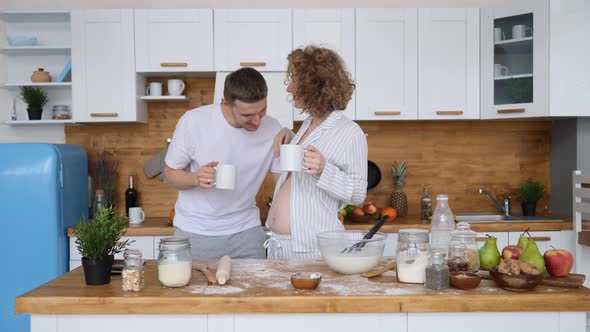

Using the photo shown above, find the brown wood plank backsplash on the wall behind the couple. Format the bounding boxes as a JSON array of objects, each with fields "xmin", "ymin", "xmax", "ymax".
[{"xmin": 66, "ymin": 78, "xmax": 551, "ymax": 218}]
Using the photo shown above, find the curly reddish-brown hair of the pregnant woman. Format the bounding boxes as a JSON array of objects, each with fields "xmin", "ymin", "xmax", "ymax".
[{"xmin": 287, "ymin": 45, "xmax": 355, "ymax": 117}]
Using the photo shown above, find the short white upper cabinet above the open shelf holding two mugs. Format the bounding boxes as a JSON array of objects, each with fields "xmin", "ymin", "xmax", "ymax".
[{"xmin": 135, "ymin": 9, "xmax": 214, "ymax": 72}]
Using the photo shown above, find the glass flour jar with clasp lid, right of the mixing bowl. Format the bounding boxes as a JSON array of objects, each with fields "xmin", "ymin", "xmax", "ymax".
[{"xmin": 396, "ymin": 229, "xmax": 430, "ymax": 284}]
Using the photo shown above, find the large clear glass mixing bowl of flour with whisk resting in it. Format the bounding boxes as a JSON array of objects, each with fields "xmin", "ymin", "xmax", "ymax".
[{"xmin": 317, "ymin": 230, "xmax": 387, "ymax": 274}]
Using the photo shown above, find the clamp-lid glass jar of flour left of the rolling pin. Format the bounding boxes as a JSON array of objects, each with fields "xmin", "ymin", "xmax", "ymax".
[{"xmin": 158, "ymin": 237, "xmax": 193, "ymax": 287}]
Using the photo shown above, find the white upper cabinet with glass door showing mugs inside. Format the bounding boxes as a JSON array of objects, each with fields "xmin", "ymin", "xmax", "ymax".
[{"xmin": 481, "ymin": 0, "xmax": 549, "ymax": 119}]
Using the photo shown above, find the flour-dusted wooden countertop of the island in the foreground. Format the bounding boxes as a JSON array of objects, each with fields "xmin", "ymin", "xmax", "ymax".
[{"xmin": 15, "ymin": 260, "xmax": 590, "ymax": 314}]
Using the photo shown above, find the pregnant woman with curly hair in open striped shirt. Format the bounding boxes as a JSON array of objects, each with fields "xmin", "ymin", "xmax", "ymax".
[{"xmin": 266, "ymin": 46, "xmax": 367, "ymax": 259}]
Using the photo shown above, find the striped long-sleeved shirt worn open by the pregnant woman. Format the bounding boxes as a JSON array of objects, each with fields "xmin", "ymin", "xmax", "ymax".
[{"xmin": 274, "ymin": 111, "xmax": 367, "ymax": 252}]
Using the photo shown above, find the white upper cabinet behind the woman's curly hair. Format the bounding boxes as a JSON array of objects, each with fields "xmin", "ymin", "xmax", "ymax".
[{"xmin": 293, "ymin": 8, "xmax": 355, "ymax": 121}]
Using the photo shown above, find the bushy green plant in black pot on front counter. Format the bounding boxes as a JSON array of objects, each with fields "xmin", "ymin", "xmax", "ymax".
[{"xmin": 74, "ymin": 207, "xmax": 130, "ymax": 285}]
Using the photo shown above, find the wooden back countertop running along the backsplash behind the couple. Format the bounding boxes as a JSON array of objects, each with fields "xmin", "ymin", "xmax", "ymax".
[{"xmin": 68, "ymin": 216, "xmax": 590, "ymax": 237}]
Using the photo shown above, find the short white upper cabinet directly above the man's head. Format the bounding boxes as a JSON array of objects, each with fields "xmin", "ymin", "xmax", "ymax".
[{"xmin": 214, "ymin": 9, "xmax": 292, "ymax": 71}]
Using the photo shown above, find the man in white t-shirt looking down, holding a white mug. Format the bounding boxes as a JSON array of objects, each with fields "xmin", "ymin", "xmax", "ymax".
[{"xmin": 164, "ymin": 68, "xmax": 291, "ymax": 259}]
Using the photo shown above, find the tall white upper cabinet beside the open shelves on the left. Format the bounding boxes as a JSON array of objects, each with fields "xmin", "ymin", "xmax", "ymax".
[{"xmin": 71, "ymin": 9, "xmax": 147, "ymax": 122}]
